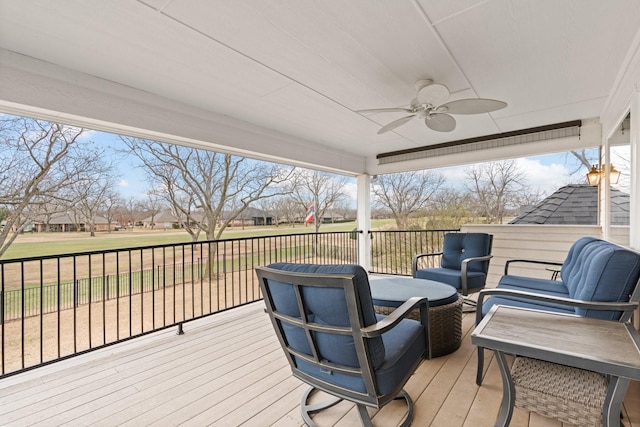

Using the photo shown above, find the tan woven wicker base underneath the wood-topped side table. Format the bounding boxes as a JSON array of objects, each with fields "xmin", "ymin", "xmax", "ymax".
[{"xmin": 511, "ymin": 357, "xmax": 608, "ymax": 426}]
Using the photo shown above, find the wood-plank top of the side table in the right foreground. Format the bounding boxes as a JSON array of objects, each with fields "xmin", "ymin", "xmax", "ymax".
[{"xmin": 471, "ymin": 305, "xmax": 640, "ymax": 380}]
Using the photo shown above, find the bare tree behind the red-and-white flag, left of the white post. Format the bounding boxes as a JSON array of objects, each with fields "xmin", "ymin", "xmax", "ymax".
[{"xmin": 289, "ymin": 169, "xmax": 347, "ymax": 233}]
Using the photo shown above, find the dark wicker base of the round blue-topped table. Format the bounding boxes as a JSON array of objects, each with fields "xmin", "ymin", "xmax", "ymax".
[{"xmin": 375, "ymin": 295, "xmax": 463, "ymax": 357}]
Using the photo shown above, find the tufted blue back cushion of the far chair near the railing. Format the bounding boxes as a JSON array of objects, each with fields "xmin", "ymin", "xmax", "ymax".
[{"xmin": 440, "ymin": 233, "xmax": 491, "ymax": 273}]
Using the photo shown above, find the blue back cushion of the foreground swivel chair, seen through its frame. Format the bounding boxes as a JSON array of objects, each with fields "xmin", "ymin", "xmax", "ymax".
[{"xmin": 268, "ymin": 263, "xmax": 385, "ymax": 369}]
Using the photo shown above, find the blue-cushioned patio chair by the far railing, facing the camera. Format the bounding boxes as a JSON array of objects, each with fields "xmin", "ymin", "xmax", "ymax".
[{"xmin": 411, "ymin": 233, "xmax": 493, "ymax": 312}]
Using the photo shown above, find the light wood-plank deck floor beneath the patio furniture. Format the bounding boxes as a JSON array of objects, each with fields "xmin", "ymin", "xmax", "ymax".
[{"xmin": 0, "ymin": 303, "xmax": 640, "ymax": 427}]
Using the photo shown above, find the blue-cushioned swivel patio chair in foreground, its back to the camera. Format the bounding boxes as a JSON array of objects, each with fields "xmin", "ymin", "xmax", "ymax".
[{"xmin": 256, "ymin": 263, "xmax": 429, "ymax": 426}]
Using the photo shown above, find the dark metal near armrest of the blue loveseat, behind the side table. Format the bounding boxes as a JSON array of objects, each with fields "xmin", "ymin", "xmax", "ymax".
[{"xmin": 476, "ymin": 289, "xmax": 638, "ymax": 325}]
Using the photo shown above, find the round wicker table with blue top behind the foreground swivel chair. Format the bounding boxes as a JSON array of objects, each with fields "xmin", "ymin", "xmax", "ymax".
[{"xmin": 369, "ymin": 276, "xmax": 462, "ymax": 357}]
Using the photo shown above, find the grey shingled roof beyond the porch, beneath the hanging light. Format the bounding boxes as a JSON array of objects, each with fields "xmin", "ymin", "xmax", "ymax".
[{"xmin": 509, "ymin": 184, "xmax": 629, "ymax": 225}]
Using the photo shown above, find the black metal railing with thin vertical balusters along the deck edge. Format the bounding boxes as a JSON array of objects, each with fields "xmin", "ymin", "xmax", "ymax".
[{"xmin": 0, "ymin": 230, "xmax": 456, "ymax": 378}]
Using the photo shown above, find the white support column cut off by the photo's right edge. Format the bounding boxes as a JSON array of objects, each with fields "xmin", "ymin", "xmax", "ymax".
[{"xmin": 629, "ymin": 90, "xmax": 640, "ymax": 250}]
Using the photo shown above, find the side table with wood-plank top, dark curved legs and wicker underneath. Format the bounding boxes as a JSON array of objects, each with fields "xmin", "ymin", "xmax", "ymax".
[{"xmin": 471, "ymin": 305, "xmax": 640, "ymax": 427}]
